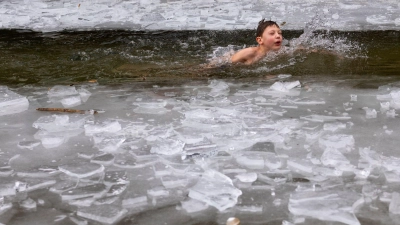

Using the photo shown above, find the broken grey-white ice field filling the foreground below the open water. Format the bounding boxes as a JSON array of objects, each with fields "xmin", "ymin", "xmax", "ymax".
[{"xmin": 0, "ymin": 79, "xmax": 400, "ymax": 225}]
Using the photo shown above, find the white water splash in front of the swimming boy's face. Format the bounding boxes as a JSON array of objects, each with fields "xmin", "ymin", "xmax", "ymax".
[{"xmin": 242, "ymin": 14, "xmax": 367, "ymax": 73}]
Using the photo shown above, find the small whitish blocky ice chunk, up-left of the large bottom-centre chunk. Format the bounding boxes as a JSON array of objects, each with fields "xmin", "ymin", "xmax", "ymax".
[{"xmin": 150, "ymin": 138, "xmax": 185, "ymax": 155}]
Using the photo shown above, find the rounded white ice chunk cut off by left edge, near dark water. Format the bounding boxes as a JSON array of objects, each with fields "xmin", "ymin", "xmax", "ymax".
[{"xmin": 0, "ymin": 86, "xmax": 29, "ymax": 116}]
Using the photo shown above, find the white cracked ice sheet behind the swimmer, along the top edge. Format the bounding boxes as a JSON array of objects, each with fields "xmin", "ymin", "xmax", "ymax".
[{"xmin": 0, "ymin": 0, "xmax": 400, "ymax": 32}]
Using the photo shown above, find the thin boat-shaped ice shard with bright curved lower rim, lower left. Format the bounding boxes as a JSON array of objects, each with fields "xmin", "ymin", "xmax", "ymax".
[{"xmin": 58, "ymin": 162, "xmax": 104, "ymax": 178}]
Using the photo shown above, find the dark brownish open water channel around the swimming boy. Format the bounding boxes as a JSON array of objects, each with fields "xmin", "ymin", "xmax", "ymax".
[{"xmin": 0, "ymin": 29, "xmax": 400, "ymax": 87}]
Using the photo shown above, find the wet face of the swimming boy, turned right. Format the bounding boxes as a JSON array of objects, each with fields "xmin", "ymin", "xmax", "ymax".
[{"xmin": 256, "ymin": 25, "xmax": 282, "ymax": 51}]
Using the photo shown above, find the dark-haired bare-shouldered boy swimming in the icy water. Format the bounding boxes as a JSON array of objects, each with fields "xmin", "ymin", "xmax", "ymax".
[{"xmin": 231, "ymin": 19, "xmax": 282, "ymax": 65}]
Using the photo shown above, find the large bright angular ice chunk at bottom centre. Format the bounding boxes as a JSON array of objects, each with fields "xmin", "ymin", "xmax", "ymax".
[{"xmin": 189, "ymin": 170, "xmax": 242, "ymax": 211}]
